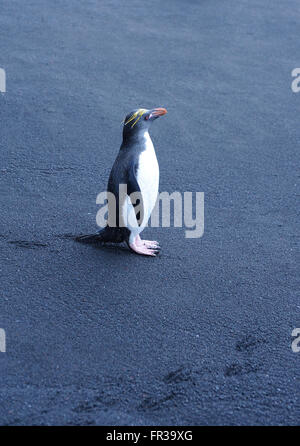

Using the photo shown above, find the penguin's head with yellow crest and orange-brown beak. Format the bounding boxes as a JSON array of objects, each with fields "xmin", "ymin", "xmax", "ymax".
[{"xmin": 123, "ymin": 108, "xmax": 167, "ymax": 136}]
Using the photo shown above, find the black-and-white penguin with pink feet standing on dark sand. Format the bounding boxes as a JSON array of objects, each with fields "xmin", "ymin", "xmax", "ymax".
[{"xmin": 75, "ymin": 108, "xmax": 167, "ymax": 257}]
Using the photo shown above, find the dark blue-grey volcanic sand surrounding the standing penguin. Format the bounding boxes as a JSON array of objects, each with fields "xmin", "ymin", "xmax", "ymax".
[{"xmin": 0, "ymin": 0, "xmax": 300, "ymax": 425}]
